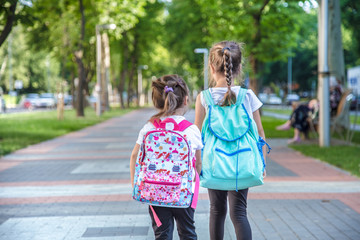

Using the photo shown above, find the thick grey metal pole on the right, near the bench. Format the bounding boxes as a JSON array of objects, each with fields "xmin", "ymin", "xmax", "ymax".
[{"xmin": 319, "ymin": 0, "xmax": 330, "ymax": 147}]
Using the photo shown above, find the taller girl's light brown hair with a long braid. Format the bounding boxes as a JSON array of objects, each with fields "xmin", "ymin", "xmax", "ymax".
[{"xmin": 209, "ymin": 41, "xmax": 242, "ymax": 106}]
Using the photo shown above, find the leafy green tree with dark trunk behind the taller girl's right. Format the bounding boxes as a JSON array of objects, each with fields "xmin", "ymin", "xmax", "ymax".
[{"xmin": 197, "ymin": 0, "xmax": 303, "ymax": 93}]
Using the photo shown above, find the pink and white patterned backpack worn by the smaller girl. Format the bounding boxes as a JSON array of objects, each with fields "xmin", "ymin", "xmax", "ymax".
[{"xmin": 133, "ymin": 118, "xmax": 199, "ymax": 225}]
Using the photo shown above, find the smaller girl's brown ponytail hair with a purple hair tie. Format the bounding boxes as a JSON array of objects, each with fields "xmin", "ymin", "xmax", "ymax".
[{"xmin": 150, "ymin": 75, "xmax": 189, "ymax": 122}]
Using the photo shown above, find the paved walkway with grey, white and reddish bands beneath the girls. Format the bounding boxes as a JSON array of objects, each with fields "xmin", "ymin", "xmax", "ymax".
[{"xmin": 0, "ymin": 109, "xmax": 360, "ymax": 240}]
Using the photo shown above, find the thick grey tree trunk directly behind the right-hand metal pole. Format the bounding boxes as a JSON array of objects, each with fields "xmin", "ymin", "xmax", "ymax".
[{"xmin": 328, "ymin": 0, "xmax": 345, "ymax": 85}]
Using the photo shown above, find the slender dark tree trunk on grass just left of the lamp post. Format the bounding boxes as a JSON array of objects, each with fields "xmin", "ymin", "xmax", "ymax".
[{"xmin": 74, "ymin": 0, "xmax": 86, "ymax": 117}]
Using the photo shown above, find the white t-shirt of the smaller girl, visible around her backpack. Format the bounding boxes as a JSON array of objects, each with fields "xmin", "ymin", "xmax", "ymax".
[{"xmin": 136, "ymin": 115, "xmax": 203, "ymax": 156}]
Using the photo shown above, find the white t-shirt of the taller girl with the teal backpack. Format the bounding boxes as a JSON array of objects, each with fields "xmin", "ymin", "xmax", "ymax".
[{"xmin": 200, "ymin": 86, "xmax": 263, "ymax": 118}]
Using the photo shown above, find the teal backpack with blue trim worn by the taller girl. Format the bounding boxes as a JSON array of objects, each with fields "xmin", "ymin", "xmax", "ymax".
[{"xmin": 200, "ymin": 88, "xmax": 271, "ymax": 191}]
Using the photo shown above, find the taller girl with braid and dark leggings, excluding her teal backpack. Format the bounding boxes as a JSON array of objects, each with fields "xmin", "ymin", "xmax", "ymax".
[{"xmin": 195, "ymin": 41, "xmax": 266, "ymax": 240}]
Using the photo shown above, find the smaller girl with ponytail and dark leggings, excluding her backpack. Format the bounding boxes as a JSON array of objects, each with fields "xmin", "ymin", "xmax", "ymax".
[{"xmin": 130, "ymin": 75, "xmax": 203, "ymax": 240}]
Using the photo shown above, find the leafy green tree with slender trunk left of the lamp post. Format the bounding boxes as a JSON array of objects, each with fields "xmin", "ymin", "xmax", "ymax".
[{"xmin": 25, "ymin": 0, "xmax": 145, "ymax": 116}]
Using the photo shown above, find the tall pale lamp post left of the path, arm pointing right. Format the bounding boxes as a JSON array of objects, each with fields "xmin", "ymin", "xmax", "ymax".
[{"xmin": 95, "ymin": 24, "xmax": 116, "ymax": 116}]
